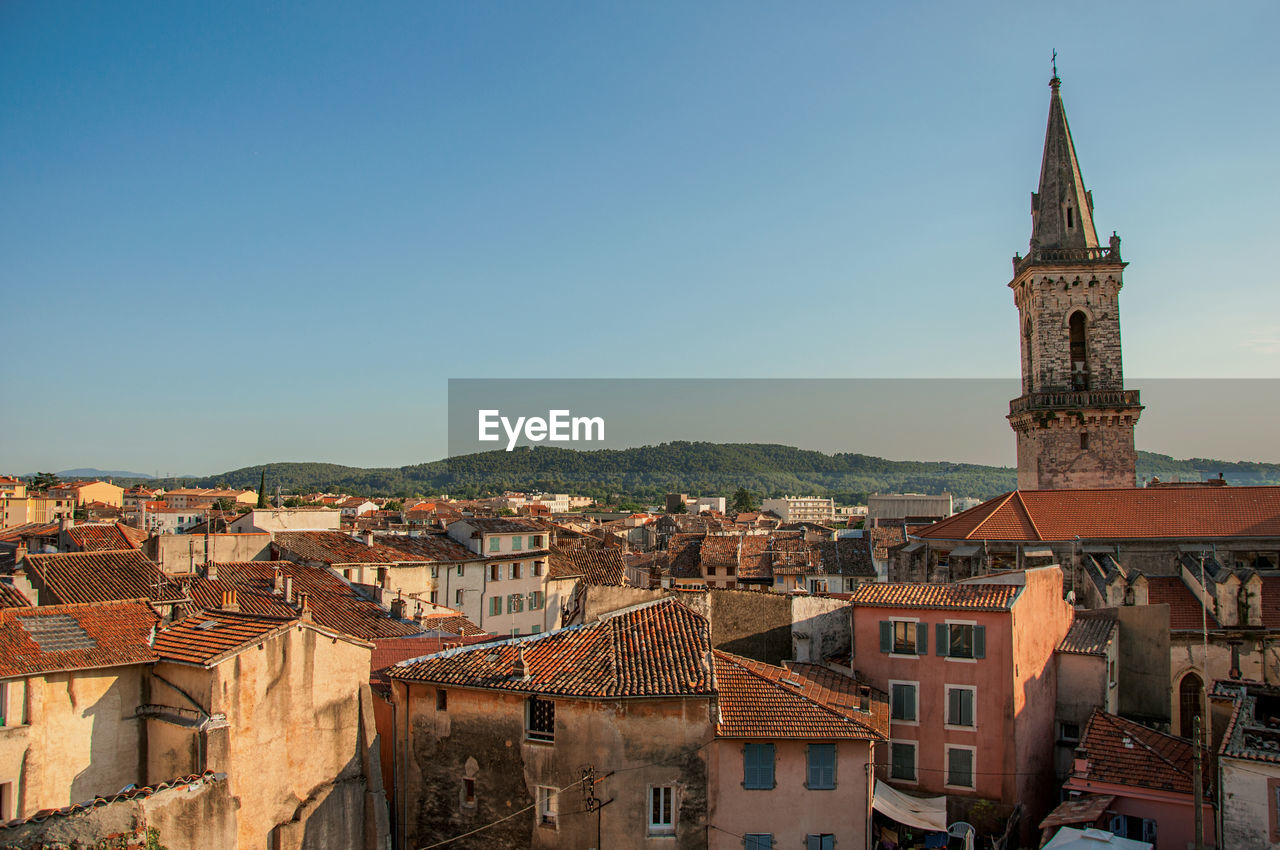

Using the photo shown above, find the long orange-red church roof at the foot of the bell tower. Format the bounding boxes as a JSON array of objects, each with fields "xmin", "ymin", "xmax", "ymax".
[{"xmin": 916, "ymin": 486, "xmax": 1280, "ymax": 540}]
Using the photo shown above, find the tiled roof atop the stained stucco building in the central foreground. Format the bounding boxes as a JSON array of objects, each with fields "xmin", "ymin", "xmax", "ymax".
[{"xmin": 388, "ymin": 599, "xmax": 713, "ymax": 698}]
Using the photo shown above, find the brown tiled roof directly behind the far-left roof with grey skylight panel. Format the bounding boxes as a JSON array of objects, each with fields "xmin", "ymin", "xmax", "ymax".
[{"xmin": 27, "ymin": 549, "xmax": 186, "ymax": 604}]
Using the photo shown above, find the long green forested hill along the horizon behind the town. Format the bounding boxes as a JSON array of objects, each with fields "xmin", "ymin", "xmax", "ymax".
[{"xmin": 112, "ymin": 442, "xmax": 1280, "ymax": 503}]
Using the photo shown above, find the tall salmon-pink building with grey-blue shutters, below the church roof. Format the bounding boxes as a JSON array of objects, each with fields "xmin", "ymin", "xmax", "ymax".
[{"xmin": 851, "ymin": 566, "xmax": 1073, "ymax": 840}]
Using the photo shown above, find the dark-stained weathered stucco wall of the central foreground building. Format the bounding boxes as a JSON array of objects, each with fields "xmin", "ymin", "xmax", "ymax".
[{"xmin": 394, "ymin": 682, "xmax": 713, "ymax": 850}]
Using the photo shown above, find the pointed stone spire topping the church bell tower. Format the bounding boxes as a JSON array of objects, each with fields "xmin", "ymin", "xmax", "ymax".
[{"xmin": 1030, "ymin": 71, "xmax": 1098, "ymax": 255}]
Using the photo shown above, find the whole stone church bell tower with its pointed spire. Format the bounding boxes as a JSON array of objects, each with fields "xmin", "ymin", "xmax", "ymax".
[{"xmin": 1009, "ymin": 73, "xmax": 1142, "ymax": 490}]
